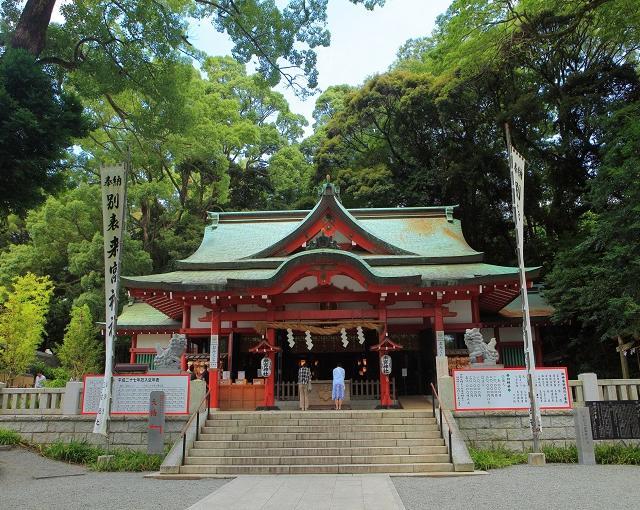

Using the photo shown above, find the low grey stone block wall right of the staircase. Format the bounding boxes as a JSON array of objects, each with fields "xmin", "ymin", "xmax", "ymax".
[{"xmin": 453, "ymin": 410, "xmax": 576, "ymax": 451}]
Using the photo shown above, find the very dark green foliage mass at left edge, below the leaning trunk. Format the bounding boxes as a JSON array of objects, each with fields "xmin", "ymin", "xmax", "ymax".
[{"xmin": 0, "ymin": 50, "xmax": 88, "ymax": 215}]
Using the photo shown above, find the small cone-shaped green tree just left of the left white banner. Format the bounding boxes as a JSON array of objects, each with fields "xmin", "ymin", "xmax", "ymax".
[{"xmin": 56, "ymin": 305, "xmax": 104, "ymax": 381}]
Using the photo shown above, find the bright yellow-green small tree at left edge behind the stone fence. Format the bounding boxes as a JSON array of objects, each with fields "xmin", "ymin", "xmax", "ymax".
[{"xmin": 0, "ymin": 273, "xmax": 53, "ymax": 386}]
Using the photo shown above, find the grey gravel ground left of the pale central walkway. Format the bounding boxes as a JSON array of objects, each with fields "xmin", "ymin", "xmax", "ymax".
[{"xmin": 0, "ymin": 448, "xmax": 229, "ymax": 510}]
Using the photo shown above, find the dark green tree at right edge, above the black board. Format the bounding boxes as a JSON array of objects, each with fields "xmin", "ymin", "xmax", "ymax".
[{"xmin": 545, "ymin": 102, "xmax": 640, "ymax": 376}]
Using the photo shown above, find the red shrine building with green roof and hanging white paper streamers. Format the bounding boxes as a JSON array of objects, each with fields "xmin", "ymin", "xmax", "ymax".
[{"xmin": 118, "ymin": 182, "xmax": 549, "ymax": 409}]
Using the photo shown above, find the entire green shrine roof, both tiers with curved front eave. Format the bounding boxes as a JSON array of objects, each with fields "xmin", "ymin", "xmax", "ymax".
[{"xmin": 123, "ymin": 184, "xmax": 538, "ymax": 294}]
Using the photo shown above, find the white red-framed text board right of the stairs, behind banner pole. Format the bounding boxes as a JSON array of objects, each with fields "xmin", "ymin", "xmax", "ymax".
[{"xmin": 453, "ymin": 367, "xmax": 571, "ymax": 411}]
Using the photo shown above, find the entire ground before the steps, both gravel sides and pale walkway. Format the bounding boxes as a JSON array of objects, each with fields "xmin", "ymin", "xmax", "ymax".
[{"xmin": 5, "ymin": 449, "xmax": 640, "ymax": 510}]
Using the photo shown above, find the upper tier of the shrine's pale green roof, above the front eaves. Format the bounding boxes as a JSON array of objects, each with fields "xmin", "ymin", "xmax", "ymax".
[{"xmin": 178, "ymin": 185, "xmax": 482, "ymax": 269}]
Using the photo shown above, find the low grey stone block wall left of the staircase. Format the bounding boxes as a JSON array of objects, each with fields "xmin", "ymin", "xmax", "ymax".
[{"xmin": 0, "ymin": 415, "xmax": 188, "ymax": 450}]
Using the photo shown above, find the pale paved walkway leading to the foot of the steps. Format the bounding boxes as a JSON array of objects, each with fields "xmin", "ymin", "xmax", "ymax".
[{"xmin": 189, "ymin": 475, "xmax": 405, "ymax": 510}]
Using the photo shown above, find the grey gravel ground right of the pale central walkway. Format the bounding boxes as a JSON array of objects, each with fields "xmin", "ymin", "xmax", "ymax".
[{"xmin": 392, "ymin": 464, "xmax": 640, "ymax": 510}]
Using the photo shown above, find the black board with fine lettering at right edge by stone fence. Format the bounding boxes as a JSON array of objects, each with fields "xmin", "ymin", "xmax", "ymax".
[{"xmin": 585, "ymin": 400, "xmax": 640, "ymax": 439}]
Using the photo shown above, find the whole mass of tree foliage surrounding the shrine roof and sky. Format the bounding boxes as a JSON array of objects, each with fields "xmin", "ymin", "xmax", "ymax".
[{"xmin": 0, "ymin": 0, "xmax": 640, "ymax": 370}]
